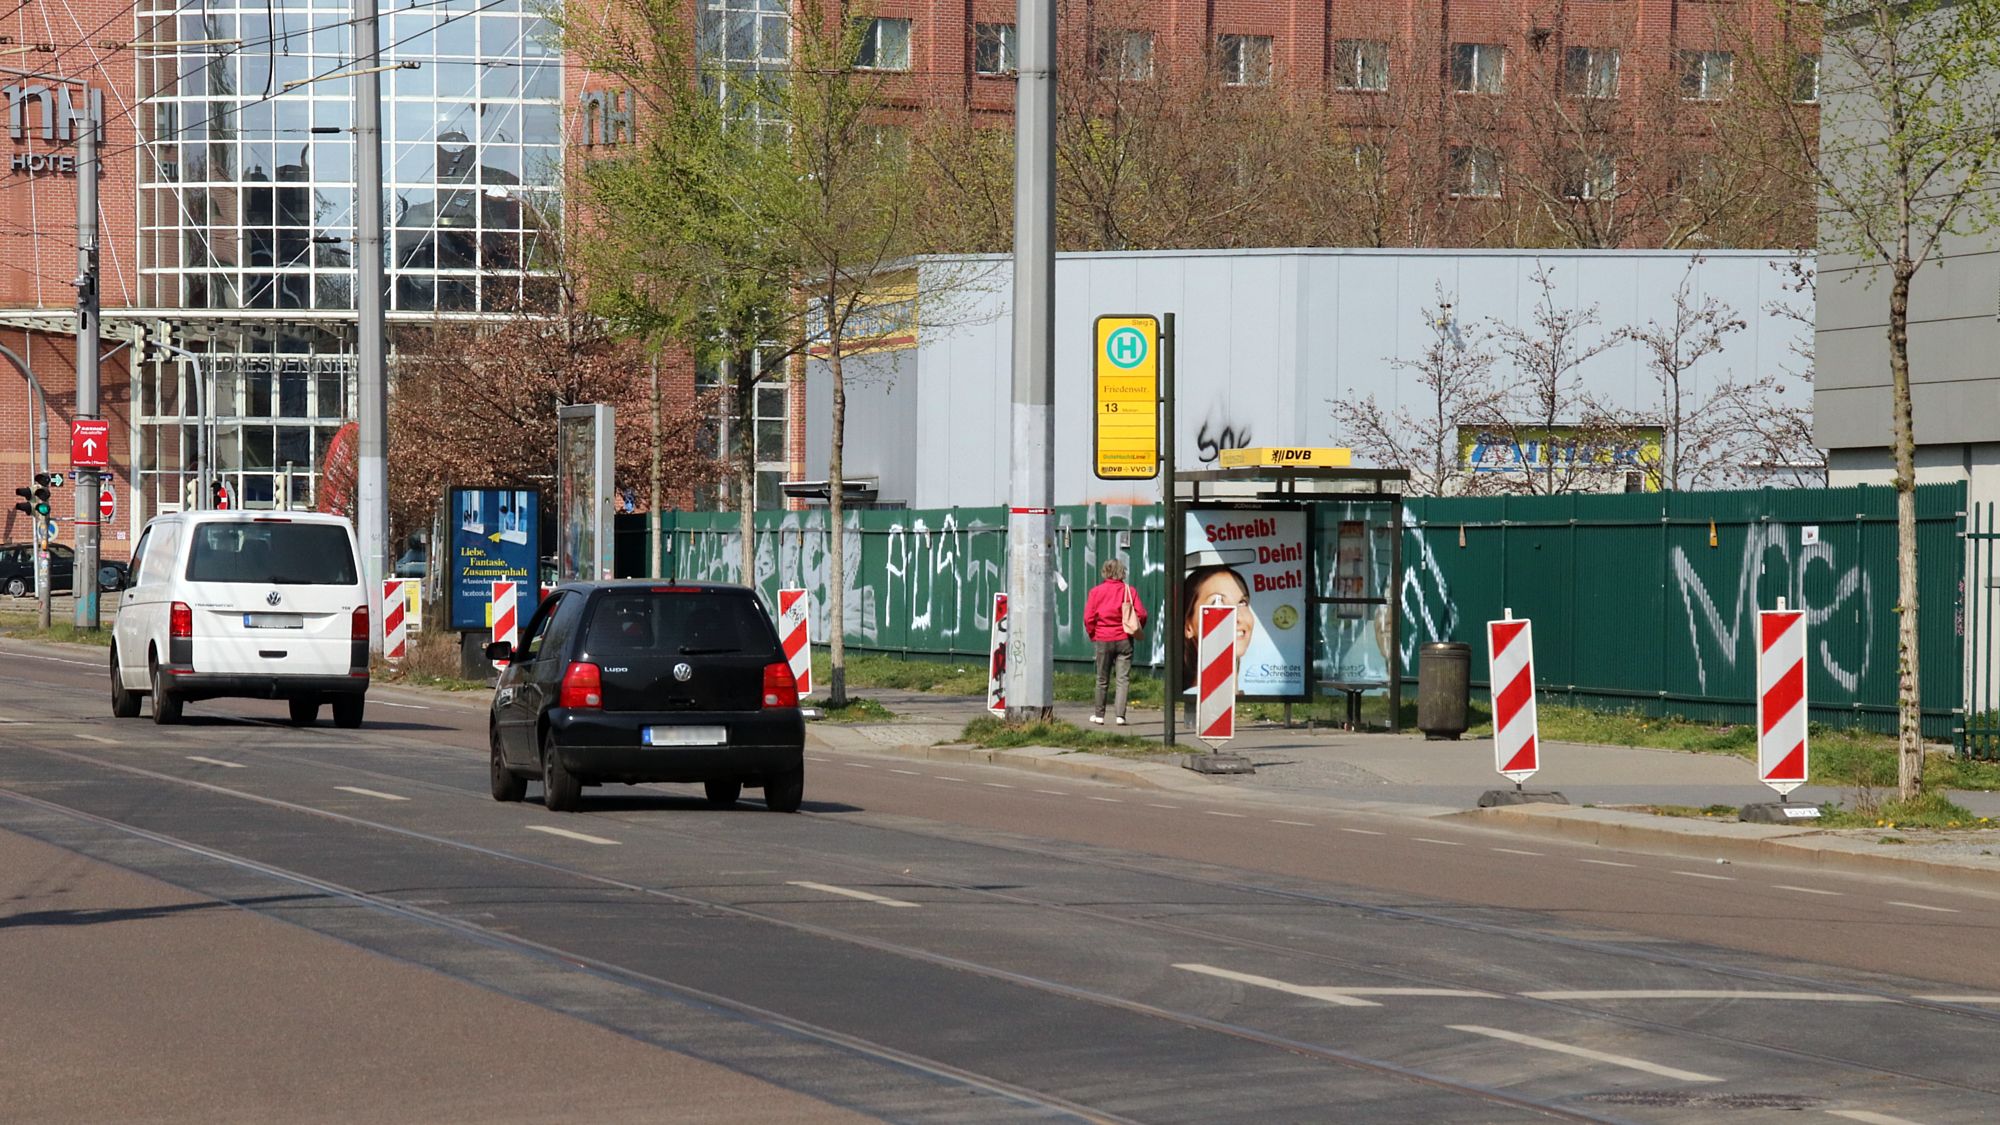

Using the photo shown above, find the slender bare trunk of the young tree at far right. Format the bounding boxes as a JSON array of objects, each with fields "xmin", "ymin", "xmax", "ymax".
[{"xmin": 1888, "ymin": 260, "xmax": 1924, "ymax": 801}]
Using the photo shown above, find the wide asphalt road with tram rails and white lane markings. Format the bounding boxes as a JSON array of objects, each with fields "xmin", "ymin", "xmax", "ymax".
[{"xmin": 0, "ymin": 643, "xmax": 2000, "ymax": 1123}]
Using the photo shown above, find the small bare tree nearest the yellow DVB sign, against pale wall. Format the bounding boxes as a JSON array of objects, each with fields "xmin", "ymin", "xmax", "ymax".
[{"xmin": 1334, "ymin": 286, "xmax": 1502, "ymax": 496}]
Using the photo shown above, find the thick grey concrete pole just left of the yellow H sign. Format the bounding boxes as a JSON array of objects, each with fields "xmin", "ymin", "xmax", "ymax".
[{"xmin": 1006, "ymin": 0, "xmax": 1056, "ymax": 723}]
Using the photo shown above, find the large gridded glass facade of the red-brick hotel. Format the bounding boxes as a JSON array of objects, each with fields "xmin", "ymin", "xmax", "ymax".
[{"xmin": 134, "ymin": 0, "xmax": 564, "ymax": 512}]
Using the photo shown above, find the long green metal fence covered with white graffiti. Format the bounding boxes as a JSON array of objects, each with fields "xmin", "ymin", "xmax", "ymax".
[{"xmin": 644, "ymin": 484, "xmax": 1968, "ymax": 736}]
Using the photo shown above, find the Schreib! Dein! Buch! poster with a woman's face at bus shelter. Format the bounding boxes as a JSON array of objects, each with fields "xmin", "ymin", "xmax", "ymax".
[{"xmin": 1178, "ymin": 508, "xmax": 1308, "ymax": 699}]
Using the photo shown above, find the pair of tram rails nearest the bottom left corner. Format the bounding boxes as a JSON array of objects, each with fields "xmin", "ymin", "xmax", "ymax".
[{"xmin": 0, "ymin": 751, "xmax": 1618, "ymax": 1123}]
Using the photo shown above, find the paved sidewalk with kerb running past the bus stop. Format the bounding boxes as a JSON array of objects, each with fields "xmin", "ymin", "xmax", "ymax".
[{"xmin": 806, "ymin": 691, "xmax": 2000, "ymax": 893}]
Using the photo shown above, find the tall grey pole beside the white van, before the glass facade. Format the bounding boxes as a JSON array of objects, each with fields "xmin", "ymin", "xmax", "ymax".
[{"xmin": 354, "ymin": 0, "xmax": 388, "ymax": 653}]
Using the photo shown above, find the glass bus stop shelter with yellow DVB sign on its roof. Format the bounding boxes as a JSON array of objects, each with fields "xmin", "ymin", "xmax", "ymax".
[{"xmin": 1166, "ymin": 450, "xmax": 1410, "ymax": 737}]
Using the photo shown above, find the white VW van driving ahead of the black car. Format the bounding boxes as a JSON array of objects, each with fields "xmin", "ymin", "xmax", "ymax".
[{"xmin": 110, "ymin": 510, "xmax": 370, "ymax": 727}]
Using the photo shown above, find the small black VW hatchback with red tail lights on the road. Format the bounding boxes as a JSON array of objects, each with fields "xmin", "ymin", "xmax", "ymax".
[{"xmin": 486, "ymin": 583, "xmax": 806, "ymax": 813}]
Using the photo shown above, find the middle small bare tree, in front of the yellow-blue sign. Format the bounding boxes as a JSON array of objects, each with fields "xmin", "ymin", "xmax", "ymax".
[{"xmin": 1484, "ymin": 266, "xmax": 1638, "ymax": 496}]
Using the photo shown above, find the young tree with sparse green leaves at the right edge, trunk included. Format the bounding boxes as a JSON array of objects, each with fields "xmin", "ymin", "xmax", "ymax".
[{"xmin": 1736, "ymin": 0, "xmax": 2000, "ymax": 799}]
